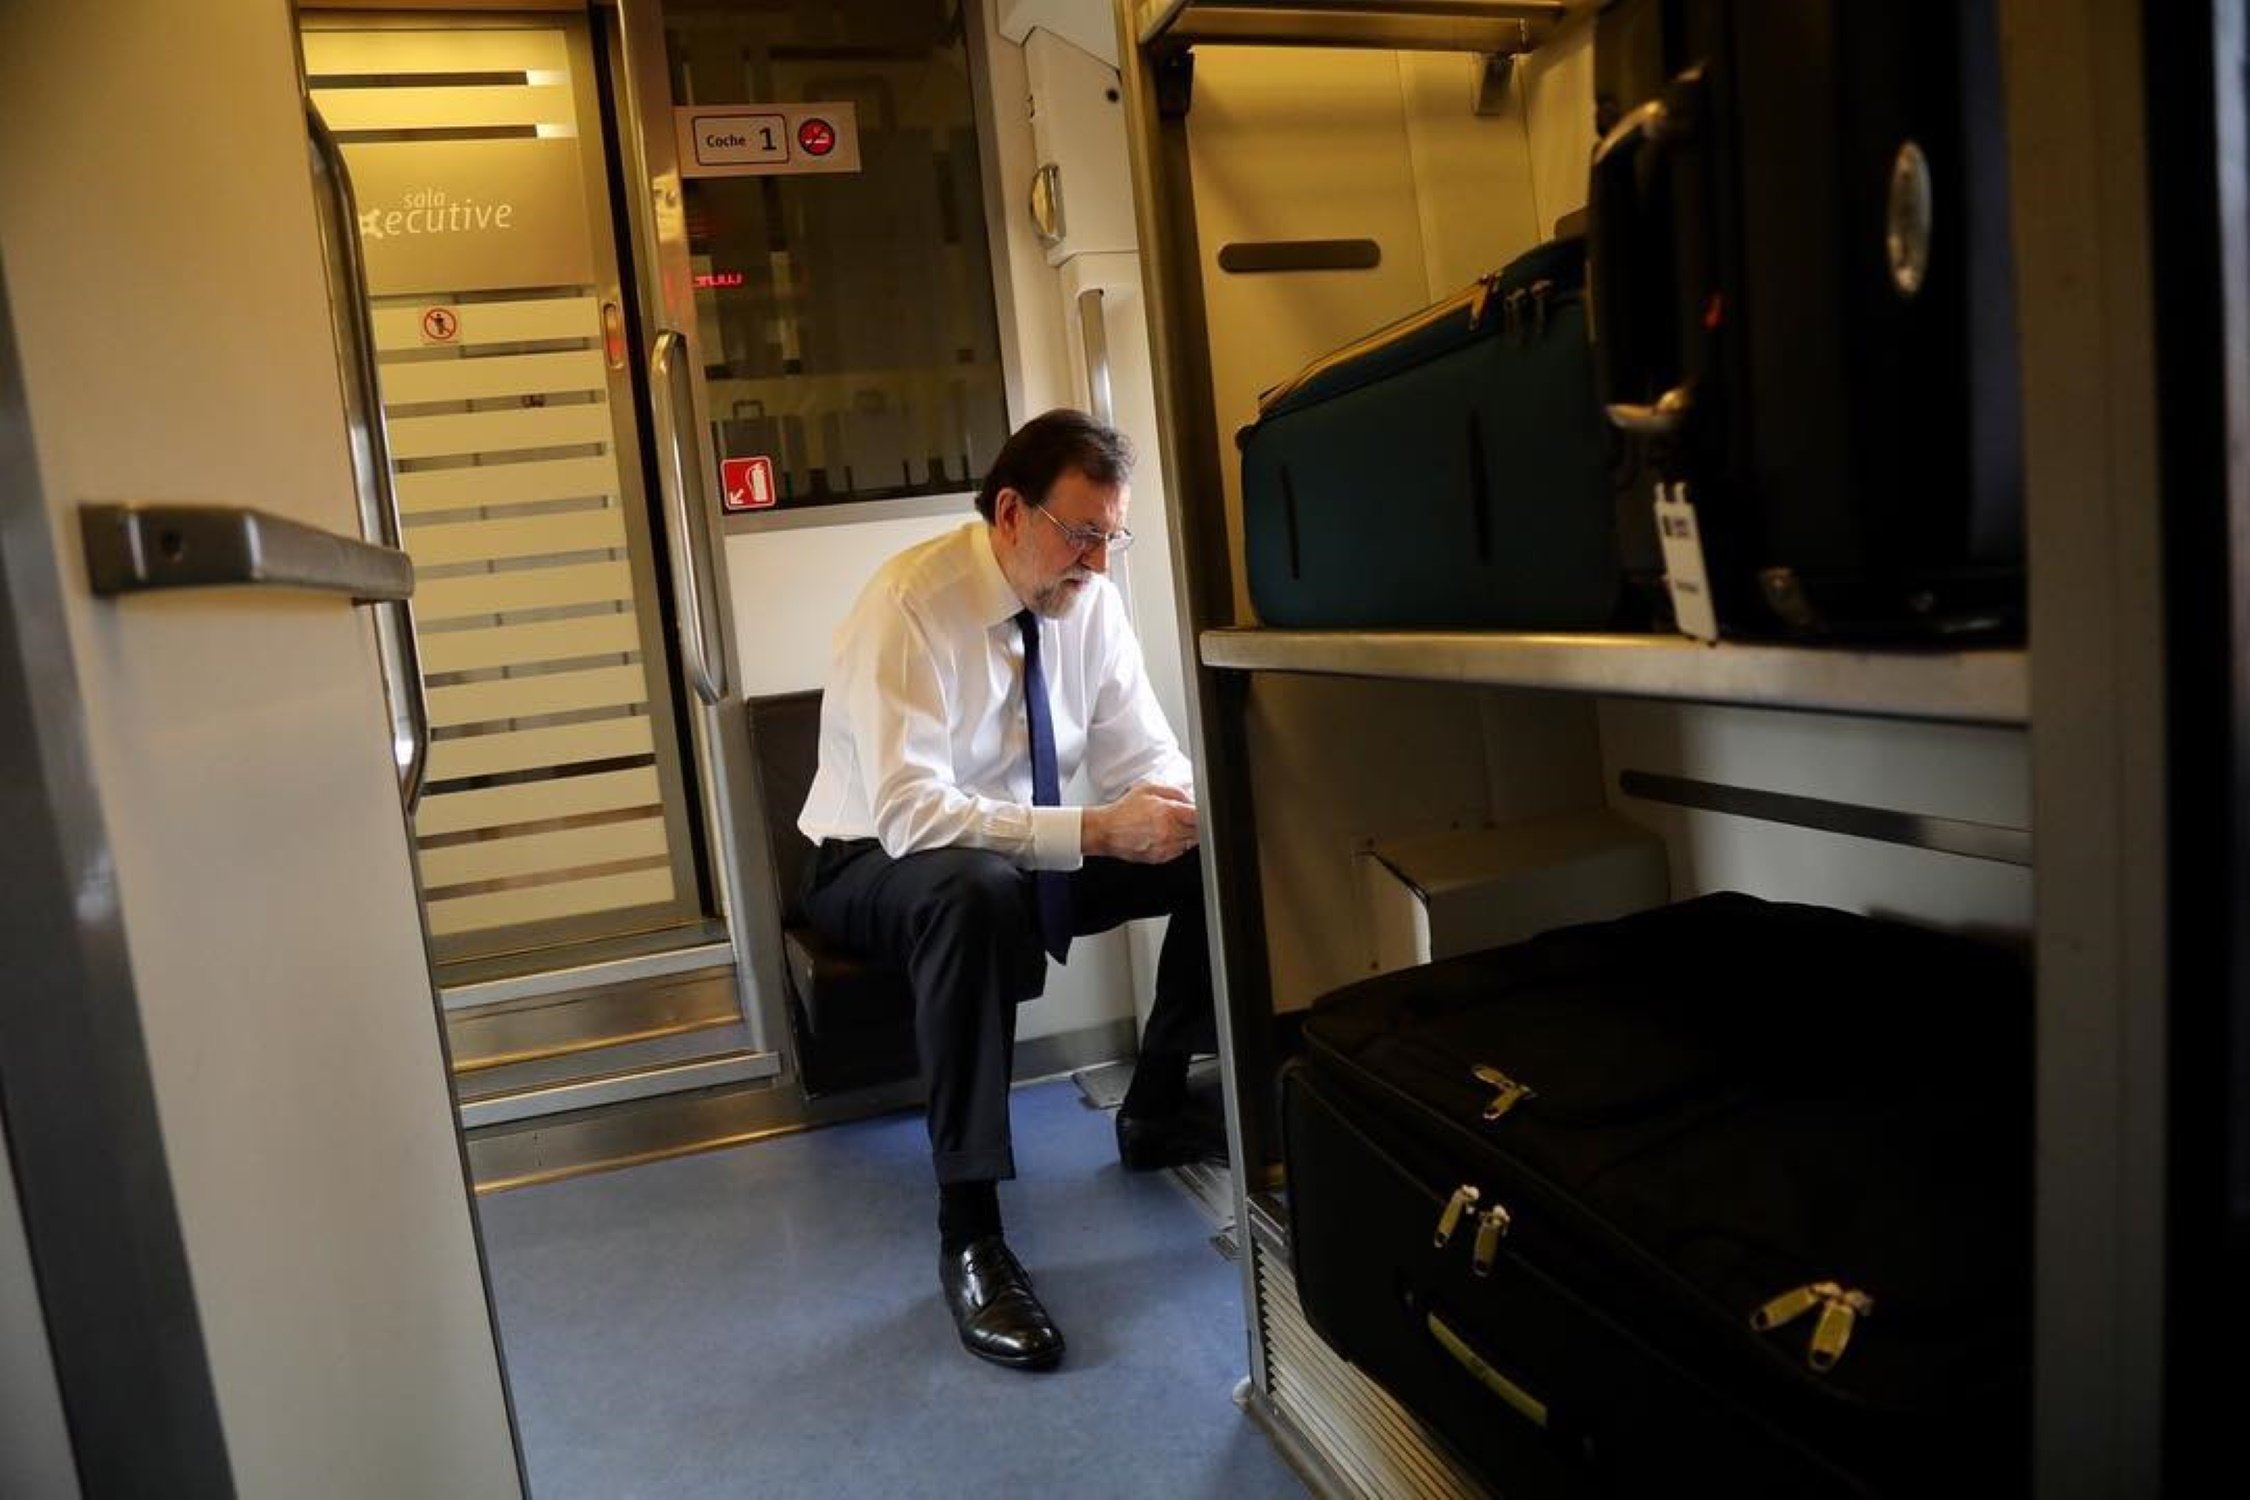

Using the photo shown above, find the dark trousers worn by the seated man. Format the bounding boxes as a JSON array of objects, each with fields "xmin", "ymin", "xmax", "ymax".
[{"xmin": 803, "ymin": 839, "xmax": 1217, "ymax": 1183}]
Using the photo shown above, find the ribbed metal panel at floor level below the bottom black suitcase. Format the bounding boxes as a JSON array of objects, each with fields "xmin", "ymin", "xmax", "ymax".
[{"xmin": 1251, "ymin": 1235, "xmax": 1487, "ymax": 1500}]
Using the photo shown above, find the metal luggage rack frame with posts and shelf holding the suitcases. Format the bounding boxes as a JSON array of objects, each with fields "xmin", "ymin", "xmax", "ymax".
[{"xmin": 1118, "ymin": 0, "xmax": 2169, "ymax": 1496}]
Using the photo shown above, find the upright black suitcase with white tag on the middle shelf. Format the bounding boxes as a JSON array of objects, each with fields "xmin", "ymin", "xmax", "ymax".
[{"xmin": 1589, "ymin": 0, "xmax": 2023, "ymax": 639}]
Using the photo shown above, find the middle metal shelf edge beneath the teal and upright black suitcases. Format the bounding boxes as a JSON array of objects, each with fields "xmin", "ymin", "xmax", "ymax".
[{"xmin": 1202, "ymin": 630, "xmax": 2032, "ymax": 724}]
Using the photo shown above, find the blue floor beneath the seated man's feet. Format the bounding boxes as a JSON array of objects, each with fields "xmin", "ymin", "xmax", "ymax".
[{"xmin": 479, "ymin": 1079, "xmax": 1305, "ymax": 1500}]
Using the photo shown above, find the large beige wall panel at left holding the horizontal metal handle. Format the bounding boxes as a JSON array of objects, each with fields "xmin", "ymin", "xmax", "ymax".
[{"xmin": 0, "ymin": 0, "xmax": 518, "ymax": 1500}]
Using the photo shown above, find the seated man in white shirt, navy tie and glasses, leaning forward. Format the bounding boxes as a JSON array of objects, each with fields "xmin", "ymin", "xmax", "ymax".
[{"xmin": 799, "ymin": 412, "xmax": 1217, "ymax": 1370}]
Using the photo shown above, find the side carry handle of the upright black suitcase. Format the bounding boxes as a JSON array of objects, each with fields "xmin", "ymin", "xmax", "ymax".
[{"xmin": 1586, "ymin": 67, "xmax": 1703, "ymax": 436}]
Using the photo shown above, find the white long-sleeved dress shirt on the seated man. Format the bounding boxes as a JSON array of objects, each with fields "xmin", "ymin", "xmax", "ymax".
[{"xmin": 797, "ymin": 519, "xmax": 1195, "ymax": 870}]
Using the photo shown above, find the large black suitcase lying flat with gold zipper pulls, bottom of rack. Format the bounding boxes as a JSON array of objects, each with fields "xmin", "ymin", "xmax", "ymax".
[{"xmin": 1283, "ymin": 893, "xmax": 2032, "ymax": 1498}]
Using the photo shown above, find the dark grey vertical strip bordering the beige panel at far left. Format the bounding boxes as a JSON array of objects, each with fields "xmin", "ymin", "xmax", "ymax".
[{"xmin": 0, "ymin": 255, "xmax": 234, "ymax": 1496}]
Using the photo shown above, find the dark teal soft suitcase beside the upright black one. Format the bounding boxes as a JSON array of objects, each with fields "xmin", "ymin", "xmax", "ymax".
[{"xmin": 1240, "ymin": 238, "xmax": 1620, "ymax": 630}]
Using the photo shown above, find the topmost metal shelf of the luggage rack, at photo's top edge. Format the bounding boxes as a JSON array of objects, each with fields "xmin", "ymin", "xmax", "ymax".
[{"xmin": 1139, "ymin": 0, "xmax": 1586, "ymax": 54}]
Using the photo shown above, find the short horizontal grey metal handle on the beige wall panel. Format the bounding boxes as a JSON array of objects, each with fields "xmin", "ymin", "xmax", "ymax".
[{"xmin": 79, "ymin": 504, "xmax": 414, "ymax": 605}]
